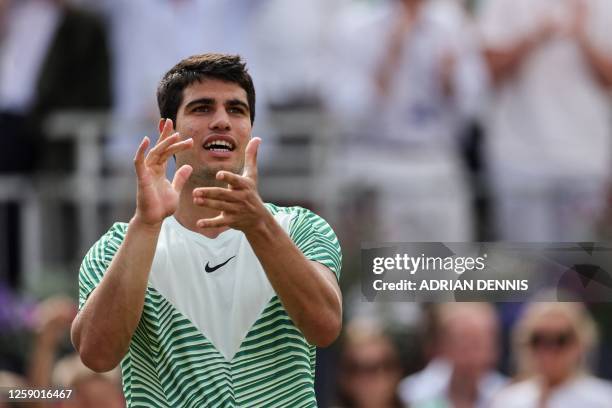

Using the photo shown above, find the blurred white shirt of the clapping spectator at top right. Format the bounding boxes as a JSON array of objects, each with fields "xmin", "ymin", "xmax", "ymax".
[{"xmin": 481, "ymin": 0, "xmax": 612, "ymax": 176}]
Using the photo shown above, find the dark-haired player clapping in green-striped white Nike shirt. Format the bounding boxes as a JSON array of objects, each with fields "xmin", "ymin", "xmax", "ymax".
[{"xmin": 71, "ymin": 54, "xmax": 342, "ymax": 407}]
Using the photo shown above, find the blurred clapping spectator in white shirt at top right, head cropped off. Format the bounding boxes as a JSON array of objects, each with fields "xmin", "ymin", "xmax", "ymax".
[{"xmin": 480, "ymin": 0, "xmax": 612, "ymax": 241}]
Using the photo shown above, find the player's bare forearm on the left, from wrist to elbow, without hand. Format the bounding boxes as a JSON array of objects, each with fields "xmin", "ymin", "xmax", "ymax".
[{"xmin": 71, "ymin": 218, "xmax": 160, "ymax": 371}]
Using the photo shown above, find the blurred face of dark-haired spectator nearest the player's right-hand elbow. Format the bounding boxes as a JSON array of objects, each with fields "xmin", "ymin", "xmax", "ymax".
[{"xmin": 339, "ymin": 337, "xmax": 402, "ymax": 408}]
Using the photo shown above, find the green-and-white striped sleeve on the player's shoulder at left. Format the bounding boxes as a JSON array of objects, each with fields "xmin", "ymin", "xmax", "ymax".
[{"xmin": 79, "ymin": 223, "xmax": 127, "ymax": 310}]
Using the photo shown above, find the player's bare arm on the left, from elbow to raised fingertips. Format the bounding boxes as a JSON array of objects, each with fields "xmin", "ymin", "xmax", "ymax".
[{"xmin": 71, "ymin": 120, "xmax": 193, "ymax": 372}]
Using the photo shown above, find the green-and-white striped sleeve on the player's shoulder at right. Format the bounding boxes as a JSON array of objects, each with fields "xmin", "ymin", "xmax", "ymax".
[{"xmin": 289, "ymin": 208, "xmax": 342, "ymax": 280}]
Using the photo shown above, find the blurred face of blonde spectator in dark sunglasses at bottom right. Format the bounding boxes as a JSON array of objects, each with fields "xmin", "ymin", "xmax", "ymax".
[{"xmin": 527, "ymin": 314, "xmax": 583, "ymax": 385}]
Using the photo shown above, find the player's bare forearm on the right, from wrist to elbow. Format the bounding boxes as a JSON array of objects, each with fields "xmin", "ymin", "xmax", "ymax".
[{"xmin": 246, "ymin": 215, "xmax": 342, "ymax": 346}]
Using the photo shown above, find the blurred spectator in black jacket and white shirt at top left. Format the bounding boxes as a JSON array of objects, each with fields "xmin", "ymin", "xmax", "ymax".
[{"xmin": 0, "ymin": 0, "xmax": 110, "ymax": 287}]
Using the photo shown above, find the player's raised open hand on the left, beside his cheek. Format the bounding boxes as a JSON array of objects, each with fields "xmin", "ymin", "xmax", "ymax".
[{"xmin": 134, "ymin": 119, "xmax": 193, "ymax": 227}]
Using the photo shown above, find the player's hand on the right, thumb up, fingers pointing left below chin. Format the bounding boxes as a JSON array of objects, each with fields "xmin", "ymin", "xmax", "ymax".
[{"xmin": 193, "ymin": 137, "xmax": 267, "ymax": 233}]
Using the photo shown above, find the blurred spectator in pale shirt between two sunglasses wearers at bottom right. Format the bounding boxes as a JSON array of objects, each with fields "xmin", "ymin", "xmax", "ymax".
[{"xmin": 399, "ymin": 303, "xmax": 506, "ymax": 408}]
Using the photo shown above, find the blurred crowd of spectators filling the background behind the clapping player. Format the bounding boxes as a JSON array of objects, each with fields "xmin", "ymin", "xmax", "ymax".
[{"xmin": 0, "ymin": 0, "xmax": 612, "ymax": 408}]
